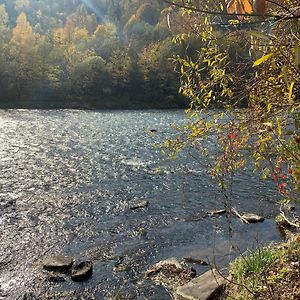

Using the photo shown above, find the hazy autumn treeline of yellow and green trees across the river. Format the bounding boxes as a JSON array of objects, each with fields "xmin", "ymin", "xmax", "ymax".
[{"xmin": 0, "ymin": 0, "xmax": 190, "ymax": 108}]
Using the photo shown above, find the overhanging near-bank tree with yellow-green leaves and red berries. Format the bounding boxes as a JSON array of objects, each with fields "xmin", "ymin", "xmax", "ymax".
[{"xmin": 165, "ymin": 0, "xmax": 300, "ymax": 200}]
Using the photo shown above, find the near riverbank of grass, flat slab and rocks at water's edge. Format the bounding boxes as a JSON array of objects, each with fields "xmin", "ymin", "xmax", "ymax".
[{"xmin": 146, "ymin": 232, "xmax": 300, "ymax": 300}]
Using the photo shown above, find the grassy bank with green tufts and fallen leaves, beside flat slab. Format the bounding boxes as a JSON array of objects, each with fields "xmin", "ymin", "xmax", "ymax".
[{"xmin": 225, "ymin": 234, "xmax": 300, "ymax": 300}]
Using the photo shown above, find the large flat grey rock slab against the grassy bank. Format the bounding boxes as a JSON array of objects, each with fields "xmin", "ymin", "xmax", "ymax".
[{"xmin": 175, "ymin": 270, "xmax": 226, "ymax": 300}]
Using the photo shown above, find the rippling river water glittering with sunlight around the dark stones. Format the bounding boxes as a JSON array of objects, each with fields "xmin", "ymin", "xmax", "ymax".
[{"xmin": 0, "ymin": 110, "xmax": 281, "ymax": 300}]
